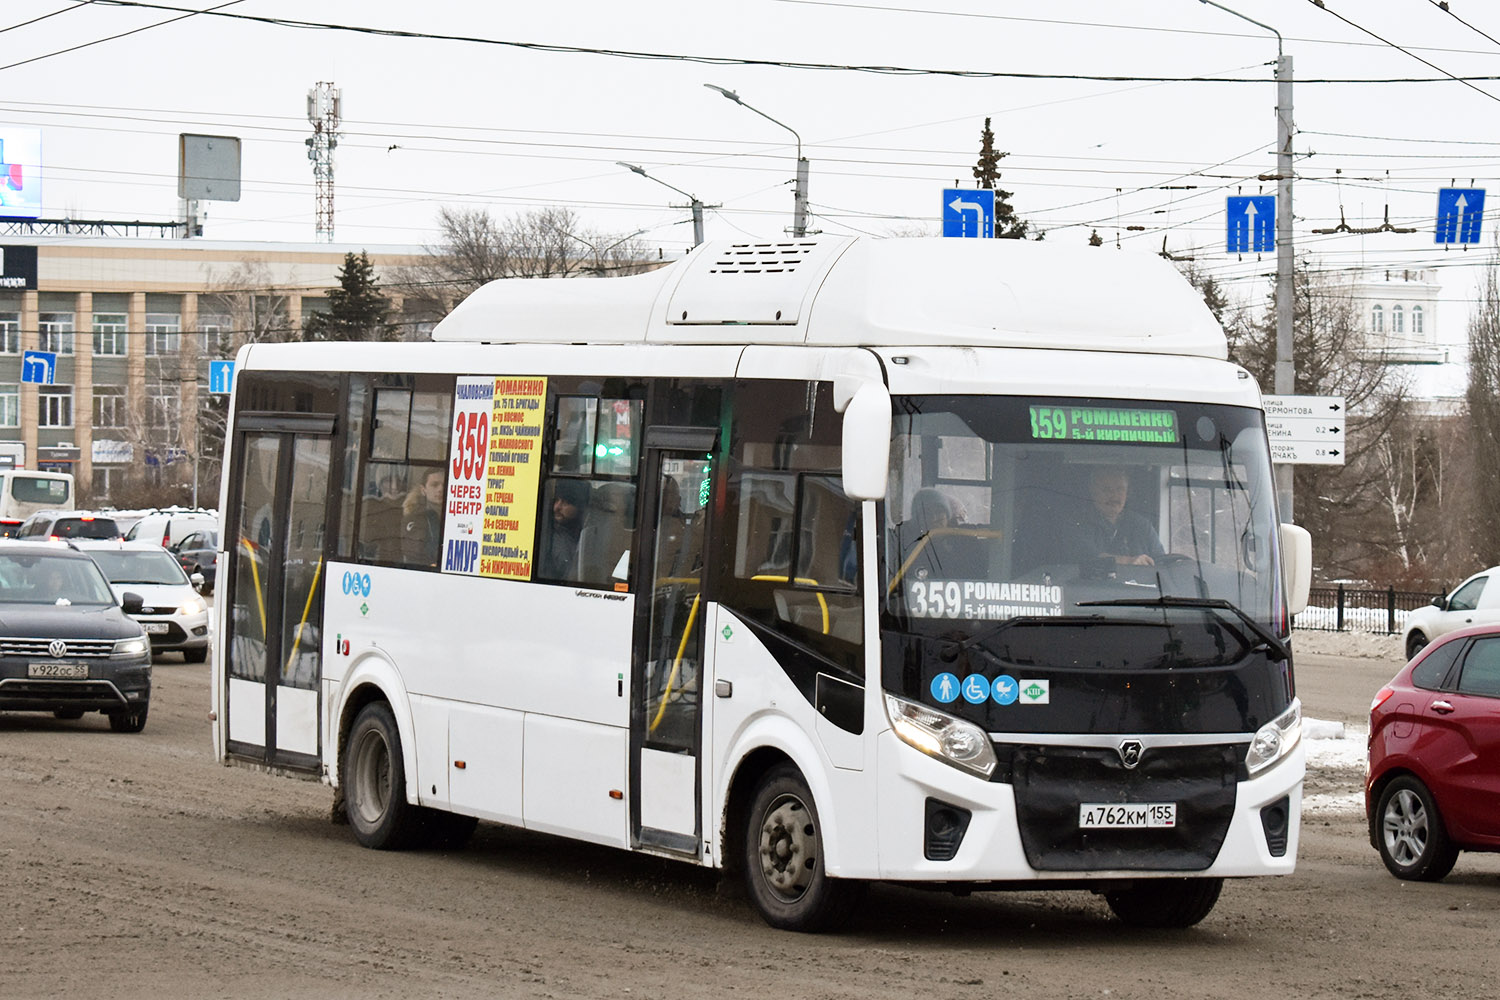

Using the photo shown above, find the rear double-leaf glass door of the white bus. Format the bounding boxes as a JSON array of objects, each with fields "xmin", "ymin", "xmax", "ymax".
[{"xmin": 221, "ymin": 427, "xmax": 333, "ymax": 771}]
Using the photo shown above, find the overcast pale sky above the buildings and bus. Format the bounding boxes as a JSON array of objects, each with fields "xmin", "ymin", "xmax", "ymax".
[{"xmin": 0, "ymin": 0, "xmax": 1500, "ymax": 319}]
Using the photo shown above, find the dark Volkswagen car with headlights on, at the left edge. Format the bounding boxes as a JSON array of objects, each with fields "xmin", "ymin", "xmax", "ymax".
[{"xmin": 0, "ymin": 540, "xmax": 152, "ymax": 733}]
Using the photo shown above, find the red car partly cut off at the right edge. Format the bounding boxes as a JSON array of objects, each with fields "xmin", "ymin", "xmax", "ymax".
[{"xmin": 1365, "ymin": 625, "xmax": 1500, "ymax": 882}]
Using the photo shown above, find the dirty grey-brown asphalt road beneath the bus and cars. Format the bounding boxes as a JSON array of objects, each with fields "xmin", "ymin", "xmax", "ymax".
[{"xmin": 0, "ymin": 644, "xmax": 1500, "ymax": 1000}]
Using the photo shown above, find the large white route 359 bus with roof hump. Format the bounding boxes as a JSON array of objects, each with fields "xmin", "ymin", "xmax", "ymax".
[{"xmin": 213, "ymin": 237, "xmax": 1310, "ymax": 930}]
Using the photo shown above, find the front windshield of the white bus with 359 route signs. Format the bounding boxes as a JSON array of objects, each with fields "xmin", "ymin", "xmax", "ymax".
[{"xmin": 881, "ymin": 396, "xmax": 1290, "ymax": 732}]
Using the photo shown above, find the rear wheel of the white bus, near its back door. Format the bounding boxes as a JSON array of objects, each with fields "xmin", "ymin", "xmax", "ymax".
[{"xmin": 339, "ymin": 702, "xmax": 425, "ymax": 850}]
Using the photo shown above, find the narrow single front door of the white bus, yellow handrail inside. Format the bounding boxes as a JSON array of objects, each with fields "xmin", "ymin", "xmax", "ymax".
[{"xmin": 630, "ymin": 427, "xmax": 716, "ymax": 858}]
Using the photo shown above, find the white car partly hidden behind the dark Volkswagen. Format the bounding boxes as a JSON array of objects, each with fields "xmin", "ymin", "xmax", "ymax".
[{"xmin": 74, "ymin": 541, "xmax": 209, "ymax": 663}]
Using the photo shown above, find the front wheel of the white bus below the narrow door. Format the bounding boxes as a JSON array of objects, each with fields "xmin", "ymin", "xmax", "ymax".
[{"xmin": 744, "ymin": 765, "xmax": 864, "ymax": 931}]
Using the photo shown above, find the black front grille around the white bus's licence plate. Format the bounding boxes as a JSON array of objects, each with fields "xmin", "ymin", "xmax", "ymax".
[{"xmin": 998, "ymin": 745, "xmax": 1245, "ymax": 871}]
